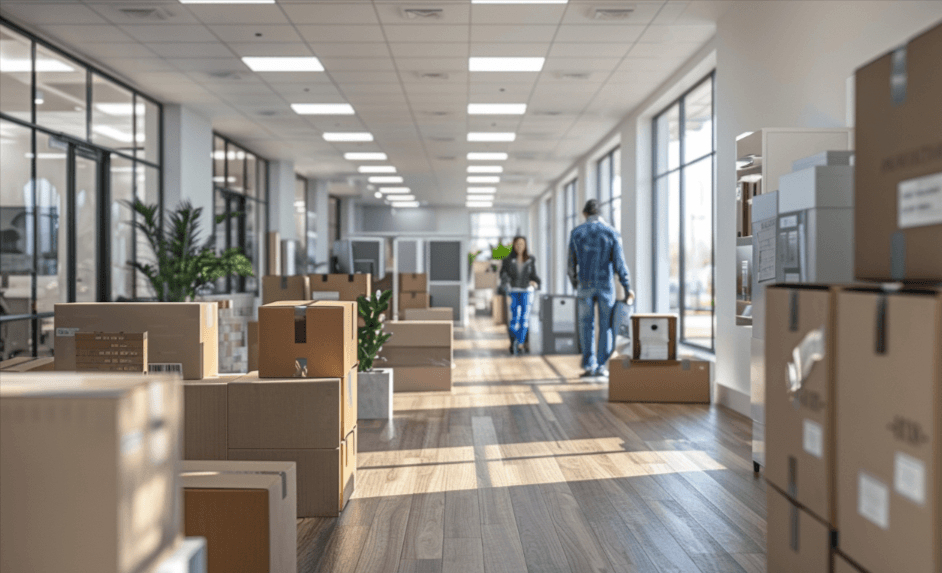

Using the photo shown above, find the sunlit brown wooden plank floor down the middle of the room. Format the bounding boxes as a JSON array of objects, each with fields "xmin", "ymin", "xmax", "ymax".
[{"xmin": 298, "ymin": 319, "xmax": 766, "ymax": 573}]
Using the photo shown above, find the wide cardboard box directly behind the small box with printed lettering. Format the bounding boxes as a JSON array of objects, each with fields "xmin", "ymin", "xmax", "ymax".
[{"xmin": 55, "ymin": 302, "xmax": 219, "ymax": 380}]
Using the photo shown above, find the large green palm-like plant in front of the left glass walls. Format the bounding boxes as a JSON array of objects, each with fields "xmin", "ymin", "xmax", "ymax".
[{"xmin": 128, "ymin": 199, "xmax": 252, "ymax": 302}]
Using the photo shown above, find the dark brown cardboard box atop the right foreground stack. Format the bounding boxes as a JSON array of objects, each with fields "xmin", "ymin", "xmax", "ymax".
[{"xmin": 854, "ymin": 25, "xmax": 942, "ymax": 283}]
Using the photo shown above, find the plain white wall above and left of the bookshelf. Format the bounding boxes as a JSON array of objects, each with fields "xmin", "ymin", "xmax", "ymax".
[{"xmin": 716, "ymin": 0, "xmax": 942, "ymax": 413}]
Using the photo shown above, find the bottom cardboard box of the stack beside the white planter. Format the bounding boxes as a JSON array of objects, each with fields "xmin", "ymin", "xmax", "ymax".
[{"xmin": 229, "ymin": 427, "xmax": 357, "ymax": 517}]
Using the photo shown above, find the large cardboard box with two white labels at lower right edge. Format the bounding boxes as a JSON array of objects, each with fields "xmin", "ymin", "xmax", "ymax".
[{"xmin": 835, "ymin": 288, "xmax": 942, "ymax": 573}]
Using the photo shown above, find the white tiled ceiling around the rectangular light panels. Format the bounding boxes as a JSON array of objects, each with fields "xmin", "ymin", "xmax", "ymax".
[{"xmin": 2, "ymin": 0, "xmax": 730, "ymax": 205}]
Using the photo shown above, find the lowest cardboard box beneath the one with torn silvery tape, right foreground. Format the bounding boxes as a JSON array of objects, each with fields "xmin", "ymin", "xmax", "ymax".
[{"xmin": 766, "ymin": 487, "xmax": 831, "ymax": 573}]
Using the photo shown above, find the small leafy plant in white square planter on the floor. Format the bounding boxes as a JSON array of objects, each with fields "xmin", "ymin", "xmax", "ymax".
[{"xmin": 357, "ymin": 290, "xmax": 393, "ymax": 420}]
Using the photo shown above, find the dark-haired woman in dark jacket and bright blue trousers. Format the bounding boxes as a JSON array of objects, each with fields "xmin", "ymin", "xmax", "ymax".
[{"xmin": 500, "ymin": 236, "xmax": 540, "ymax": 354}]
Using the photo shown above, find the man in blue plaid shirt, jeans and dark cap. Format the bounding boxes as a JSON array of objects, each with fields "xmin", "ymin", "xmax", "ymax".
[{"xmin": 569, "ymin": 199, "xmax": 635, "ymax": 376}]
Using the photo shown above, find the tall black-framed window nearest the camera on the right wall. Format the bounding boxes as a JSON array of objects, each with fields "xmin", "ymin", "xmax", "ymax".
[{"xmin": 653, "ymin": 74, "xmax": 716, "ymax": 350}]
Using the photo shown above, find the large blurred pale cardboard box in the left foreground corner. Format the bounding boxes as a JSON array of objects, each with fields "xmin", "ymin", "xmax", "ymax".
[{"xmin": 0, "ymin": 372, "xmax": 183, "ymax": 573}]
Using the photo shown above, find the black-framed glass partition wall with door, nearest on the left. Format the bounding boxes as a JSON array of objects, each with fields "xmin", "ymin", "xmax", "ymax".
[{"xmin": 0, "ymin": 18, "xmax": 163, "ymax": 359}]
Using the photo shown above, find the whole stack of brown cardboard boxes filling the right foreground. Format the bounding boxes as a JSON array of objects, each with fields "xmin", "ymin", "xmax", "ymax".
[{"xmin": 765, "ymin": 20, "xmax": 942, "ymax": 573}]
